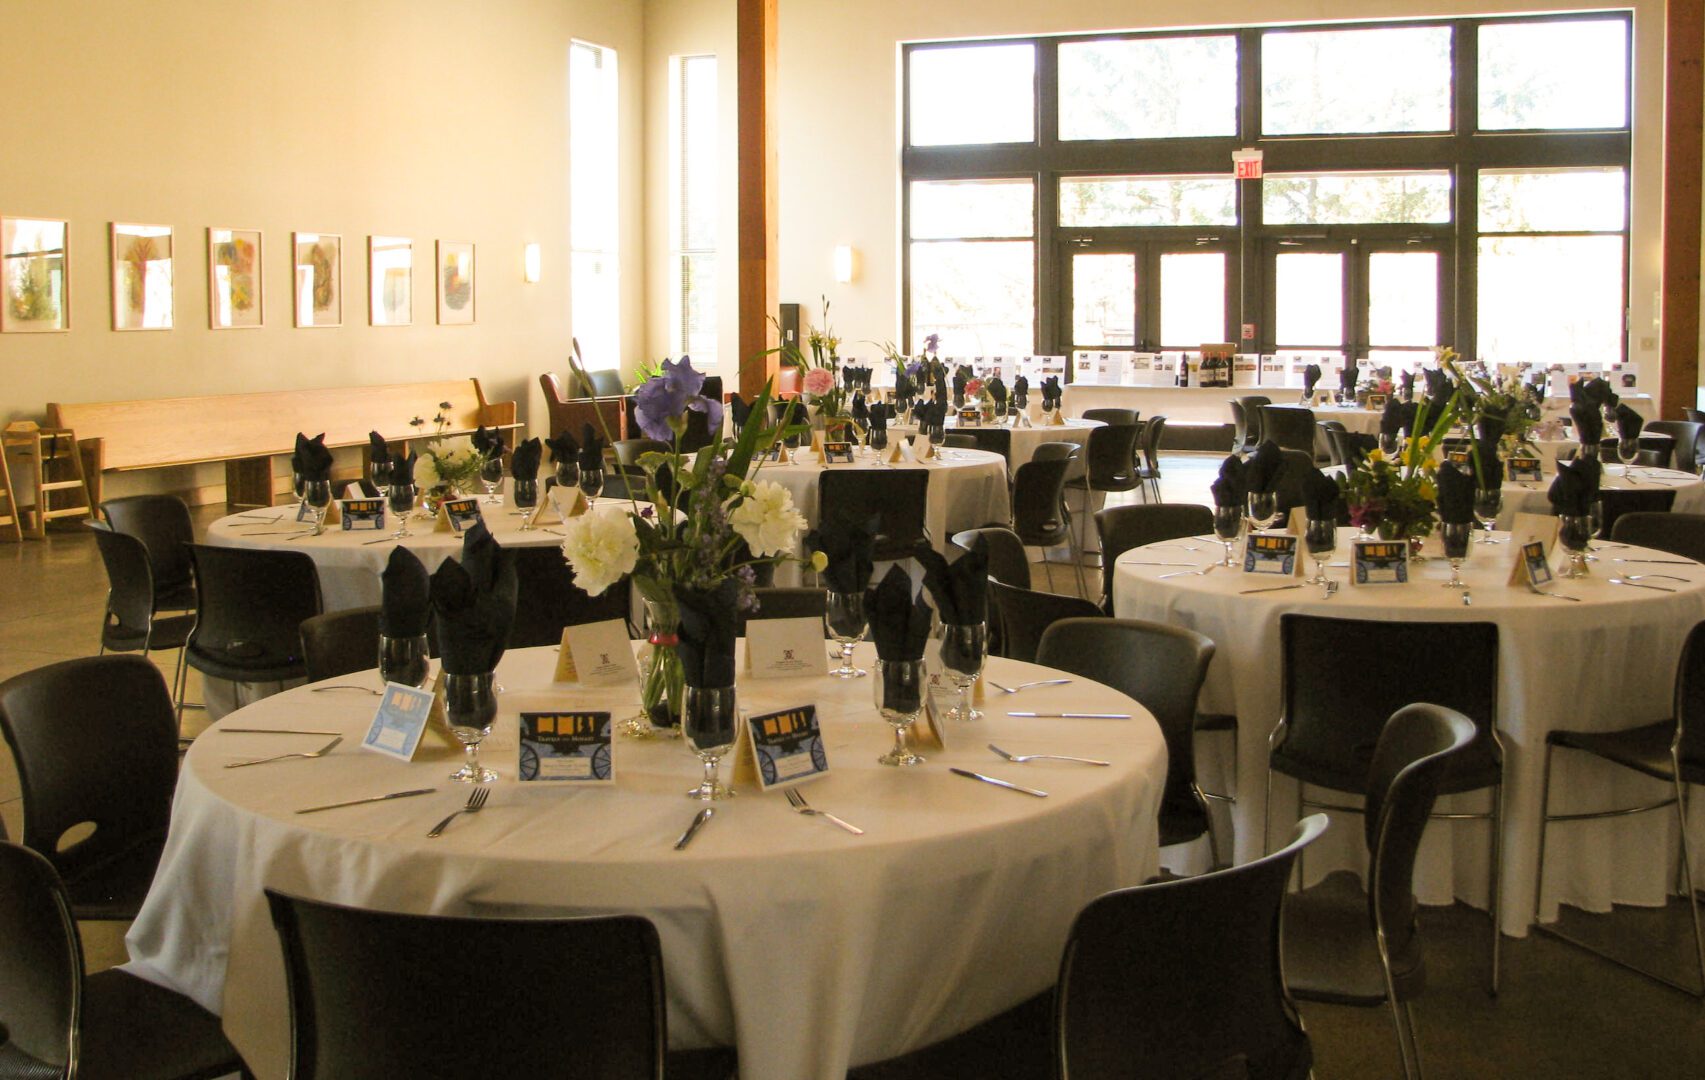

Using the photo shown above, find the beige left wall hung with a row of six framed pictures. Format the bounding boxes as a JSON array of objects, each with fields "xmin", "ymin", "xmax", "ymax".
[{"xmin": 0, "ymin": 0, "xmax": 644, "ymax": 490}]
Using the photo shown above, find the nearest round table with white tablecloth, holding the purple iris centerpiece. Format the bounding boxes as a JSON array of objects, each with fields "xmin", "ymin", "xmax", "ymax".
[{"xmin": 126, "ymin": 645, "xmax": 1166, "ymax": 1080}]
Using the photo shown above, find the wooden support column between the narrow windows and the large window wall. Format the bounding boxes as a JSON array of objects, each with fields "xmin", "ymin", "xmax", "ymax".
[{"xmin": 735, "ymin": 0, "xmax": 780, "ymax": 398}]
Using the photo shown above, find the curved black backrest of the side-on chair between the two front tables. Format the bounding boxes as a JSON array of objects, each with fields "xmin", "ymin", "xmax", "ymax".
[{"xmin": 1362, "ymin": 703, "xmax": 1483, "ymax": 1000}]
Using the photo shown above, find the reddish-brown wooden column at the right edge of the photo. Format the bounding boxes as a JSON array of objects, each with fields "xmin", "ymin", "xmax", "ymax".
[{"xmin": 1657, "ymin": 0, "xmax": 1705, "ymax": 420}]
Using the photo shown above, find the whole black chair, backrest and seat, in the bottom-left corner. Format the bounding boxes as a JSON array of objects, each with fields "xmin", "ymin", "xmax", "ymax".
[{"xmin": 0, "ymin": 843, "xmax": 249, "ymax": 1080}]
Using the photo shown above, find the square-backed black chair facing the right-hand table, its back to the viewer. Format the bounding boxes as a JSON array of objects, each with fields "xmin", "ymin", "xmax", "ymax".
[{"xmin": 1263, "ymin": 614, "xmax": 1504, "ymax": 993}]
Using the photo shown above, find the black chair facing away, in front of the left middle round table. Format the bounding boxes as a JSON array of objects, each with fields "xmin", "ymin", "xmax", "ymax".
[{"xmin": 188, "ymin": 544, "xmax": 321, "ymax": 682}]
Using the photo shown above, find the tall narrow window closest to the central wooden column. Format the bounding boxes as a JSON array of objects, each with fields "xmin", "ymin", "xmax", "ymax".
[{"xmin": 670, "ymin": 56, "xmax": 716, "ymax": 370}]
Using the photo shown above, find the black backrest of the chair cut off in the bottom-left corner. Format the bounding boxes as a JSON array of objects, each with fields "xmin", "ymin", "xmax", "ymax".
[{"xmin": 0, "ymin": 841, "xmax": 84, "ymax": 1078}]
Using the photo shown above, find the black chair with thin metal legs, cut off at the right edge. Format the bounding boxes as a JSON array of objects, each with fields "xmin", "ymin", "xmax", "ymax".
[{"xmin": 1533, "ymin": 623, "xmax": 1705, "ymax": 998}]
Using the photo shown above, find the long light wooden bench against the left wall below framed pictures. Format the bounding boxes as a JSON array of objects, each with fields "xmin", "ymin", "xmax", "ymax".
[{"xmin": 48, "ymin": 379, "xmax": 518, "ymax": 507}]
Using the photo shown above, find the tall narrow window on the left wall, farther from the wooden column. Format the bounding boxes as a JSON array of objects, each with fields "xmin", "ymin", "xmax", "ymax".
[{"xmin": 568, "ymin": 41, "xmax": 622, "ymax": 370}]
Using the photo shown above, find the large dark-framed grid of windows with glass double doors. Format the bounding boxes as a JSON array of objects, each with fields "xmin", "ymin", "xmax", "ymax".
[{"xmin": 902, "ymin": 12, "xmax": 1630, "ymax": 363}]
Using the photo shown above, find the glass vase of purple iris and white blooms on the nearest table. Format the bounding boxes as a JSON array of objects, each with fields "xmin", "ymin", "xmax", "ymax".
[{"xmin": 563, "ymin": 357, "xmax": 806, "ymax": 732}]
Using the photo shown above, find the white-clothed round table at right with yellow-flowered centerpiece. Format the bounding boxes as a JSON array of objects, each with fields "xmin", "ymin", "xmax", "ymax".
[{"xmin": 1113, "ymin": 529, "xmax": 1705, "ymax": 935}]
